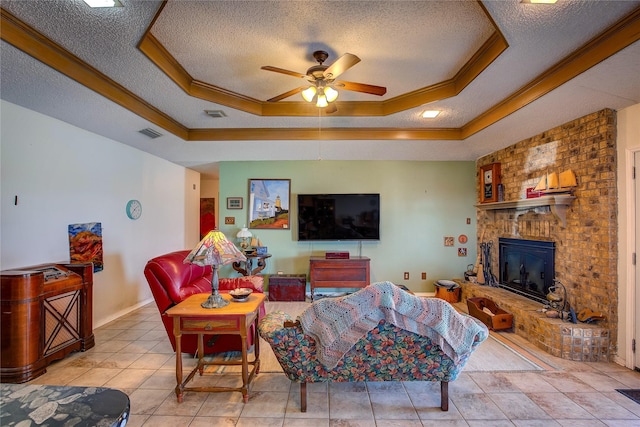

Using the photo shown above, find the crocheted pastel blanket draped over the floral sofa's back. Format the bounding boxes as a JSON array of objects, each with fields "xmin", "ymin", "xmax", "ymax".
[{"xmin": 299, "ymin": 282, "xmax": 488, "ymax": 369}]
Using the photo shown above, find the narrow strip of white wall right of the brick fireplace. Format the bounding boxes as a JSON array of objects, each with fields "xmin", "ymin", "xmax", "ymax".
[{"xmin": 617, "ymin": 104, "xmax": 640, "ymax": 368}]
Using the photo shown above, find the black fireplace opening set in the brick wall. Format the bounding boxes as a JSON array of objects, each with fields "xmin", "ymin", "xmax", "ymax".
[{"xmin": 498, "ymin": 237, "xmax": 556, "ymax": 304}]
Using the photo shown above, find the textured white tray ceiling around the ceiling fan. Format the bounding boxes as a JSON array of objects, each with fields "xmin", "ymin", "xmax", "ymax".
[{"xmin": 0, "ymin": 0, "xmax": 640, "ymax": 175}]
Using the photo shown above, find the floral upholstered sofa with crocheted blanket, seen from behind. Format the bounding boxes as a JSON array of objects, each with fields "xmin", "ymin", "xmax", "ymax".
[{"xmin": 258, "ymin": 282, "xmax": 488, "ymax": 412}]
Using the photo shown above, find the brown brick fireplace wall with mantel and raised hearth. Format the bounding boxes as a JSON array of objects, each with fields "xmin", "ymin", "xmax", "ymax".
[{"xmin": 472, "ymin": 109, "xmax": 618, "ymax": 361}]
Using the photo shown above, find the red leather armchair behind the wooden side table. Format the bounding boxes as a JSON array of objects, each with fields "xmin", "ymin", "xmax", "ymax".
[{"xmin": 144, "ymin": 250, "xmax": 265, "ymax": 354}]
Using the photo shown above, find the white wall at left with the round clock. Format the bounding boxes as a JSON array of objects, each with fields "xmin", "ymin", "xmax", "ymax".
[{"xmin": 0, "ymin": 101, "xmax": 200, "ymax": 327}]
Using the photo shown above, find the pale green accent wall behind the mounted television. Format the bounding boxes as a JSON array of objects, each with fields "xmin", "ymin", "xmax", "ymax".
[{"xmin": 217, "ymin": 160, "xmax": 476, "ymax": 292}]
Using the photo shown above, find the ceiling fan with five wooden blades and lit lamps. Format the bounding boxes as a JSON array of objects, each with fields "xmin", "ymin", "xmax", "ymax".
[{"xmin": 261, "ymin": 50, "xmax": 387, "ymax": 111}]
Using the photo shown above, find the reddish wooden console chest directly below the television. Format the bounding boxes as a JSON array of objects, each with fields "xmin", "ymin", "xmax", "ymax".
[{"xmin": 310, "ymin": 256, "xmax": 370, "ymax": 301}]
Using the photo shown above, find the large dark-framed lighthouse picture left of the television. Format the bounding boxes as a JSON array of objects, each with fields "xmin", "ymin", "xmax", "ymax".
[{"xmin": 248, "ymin": 179, "xmax": 291, "ymax": 230}]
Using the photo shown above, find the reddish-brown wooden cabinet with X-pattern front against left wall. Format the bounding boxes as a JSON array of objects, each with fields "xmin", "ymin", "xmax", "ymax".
[{"xmin": 0, "ymin": 263, "xmax": 95, "ymax": 383}]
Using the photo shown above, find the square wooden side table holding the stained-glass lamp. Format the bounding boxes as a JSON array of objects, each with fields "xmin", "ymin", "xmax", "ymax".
[{"xmin": 166, "ymin": 293, "xmax": 265, "ymax": 403}]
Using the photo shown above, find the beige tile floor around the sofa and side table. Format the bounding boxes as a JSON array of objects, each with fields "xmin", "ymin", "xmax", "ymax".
[{"xmin": 31, "ymin": 303, "xmax": 640, "ymax": 427}]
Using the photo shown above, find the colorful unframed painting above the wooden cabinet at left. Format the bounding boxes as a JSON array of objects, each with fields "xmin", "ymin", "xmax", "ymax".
[{"xmin": 69, "ymin": 222, "xmax": 104, "ymax": 273}]
